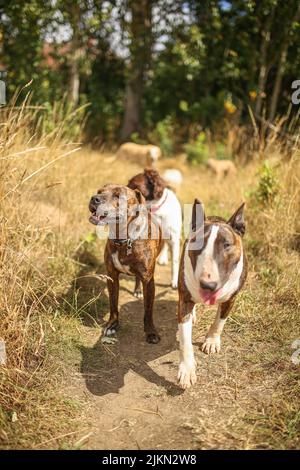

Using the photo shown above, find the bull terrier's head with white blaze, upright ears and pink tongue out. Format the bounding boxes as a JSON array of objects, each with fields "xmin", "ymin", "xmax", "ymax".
[{"xmin": 188, "ymin": 199, "xmax": 245, "ymax": 305}]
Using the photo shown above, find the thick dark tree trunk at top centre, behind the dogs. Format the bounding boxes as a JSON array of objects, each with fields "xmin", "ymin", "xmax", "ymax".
[{"xmin": 121, "ymin": 0, "xmax": 152, "ymax": 141}]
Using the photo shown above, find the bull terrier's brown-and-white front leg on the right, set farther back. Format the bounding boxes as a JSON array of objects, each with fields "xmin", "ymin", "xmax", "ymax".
[{"xmin": 201, "ymin": 299, "xmax": 234, "ymax": 354}]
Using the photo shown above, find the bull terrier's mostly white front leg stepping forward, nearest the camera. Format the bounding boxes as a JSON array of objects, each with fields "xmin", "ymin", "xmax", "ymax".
[{"xmin": 178, "ymin": 300, "xmax": 197, "ymax": 388}]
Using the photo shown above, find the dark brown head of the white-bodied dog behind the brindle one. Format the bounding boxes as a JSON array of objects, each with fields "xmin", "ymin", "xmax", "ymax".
[{"xmin": 128, "ymin": 168, "xmax": 166, "ymax": 201}]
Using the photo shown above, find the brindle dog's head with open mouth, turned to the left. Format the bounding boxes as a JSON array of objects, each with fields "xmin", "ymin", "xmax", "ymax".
[{"xmin": 89, "ymin": 184, "xmax": 145, "ymax": 225}]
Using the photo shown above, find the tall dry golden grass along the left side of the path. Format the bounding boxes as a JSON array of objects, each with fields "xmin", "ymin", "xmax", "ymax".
[{"xmin": 0, "ymin": 95, "xmax": 85, "ymax": 447}]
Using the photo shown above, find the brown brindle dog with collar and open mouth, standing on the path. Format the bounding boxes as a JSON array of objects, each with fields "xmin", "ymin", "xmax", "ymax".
[{"xmin": 89, "ymin": 184, "xmax": 162, "ymax": 343}]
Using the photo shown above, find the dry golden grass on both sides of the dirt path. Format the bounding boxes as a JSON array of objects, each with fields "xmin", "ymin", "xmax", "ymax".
[{"xmin": 0, "ymin": 98, "xmax": 300, "ymax": 448}]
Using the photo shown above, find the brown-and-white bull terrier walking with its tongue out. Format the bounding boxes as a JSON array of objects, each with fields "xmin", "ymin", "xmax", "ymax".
[{"xmin": 178, "ymin": 199, "xmax": 247, "ymax": 388}]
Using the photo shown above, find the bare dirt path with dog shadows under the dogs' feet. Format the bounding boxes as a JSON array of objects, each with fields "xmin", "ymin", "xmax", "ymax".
[{"xmin": 63, "ymin": 260, "xmax": 266, "ymax": 449}]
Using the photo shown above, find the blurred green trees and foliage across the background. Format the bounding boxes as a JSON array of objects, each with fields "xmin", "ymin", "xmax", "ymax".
[{"xmin": 0, "ymin": 0, "xmax": 300, "ymax": 146}]
